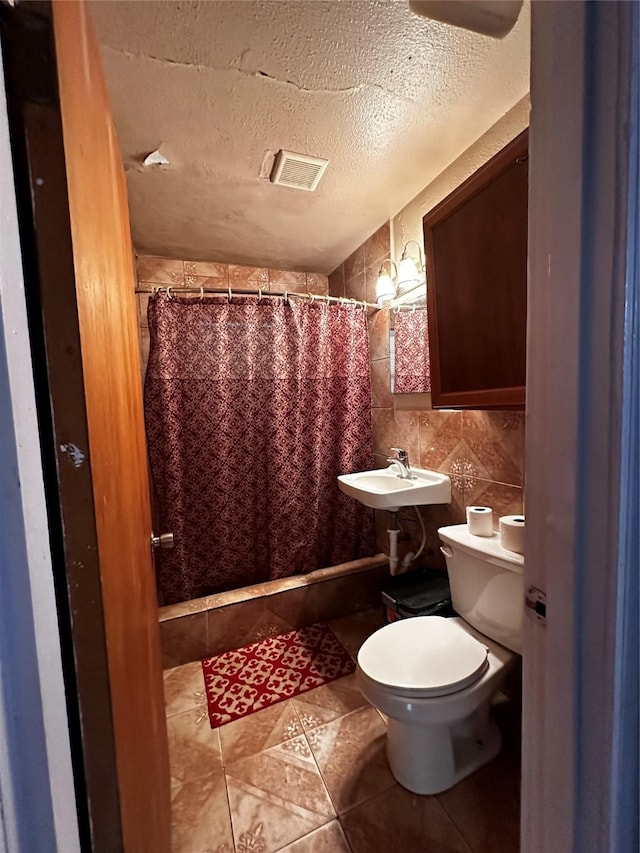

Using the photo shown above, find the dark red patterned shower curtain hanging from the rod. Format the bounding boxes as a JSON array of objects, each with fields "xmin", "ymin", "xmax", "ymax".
[{"xmin": 145, "ymin": 294, "xmax": 373, "ymax": 604}]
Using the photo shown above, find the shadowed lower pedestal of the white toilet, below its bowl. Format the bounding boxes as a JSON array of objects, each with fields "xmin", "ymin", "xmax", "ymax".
[{"xmin": 387, "ymin": 708, "xmax": 501, "ymax": 794}]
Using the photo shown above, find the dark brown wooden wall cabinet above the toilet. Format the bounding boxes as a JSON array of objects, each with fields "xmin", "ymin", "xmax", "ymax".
[{"xmin": 423, "ymin": 131, "xmax": 528, "ymax": 409}]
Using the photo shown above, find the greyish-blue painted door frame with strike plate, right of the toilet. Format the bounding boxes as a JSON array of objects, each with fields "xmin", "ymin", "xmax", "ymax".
[{"xmin": 522, "ymin": 0, "xmax": 632, "ymax": 853}]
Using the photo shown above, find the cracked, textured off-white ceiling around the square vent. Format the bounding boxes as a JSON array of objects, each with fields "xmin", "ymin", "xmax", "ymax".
[{"xmin": 91, "ymin": 0, "xmax": 529, "ymax": 272}]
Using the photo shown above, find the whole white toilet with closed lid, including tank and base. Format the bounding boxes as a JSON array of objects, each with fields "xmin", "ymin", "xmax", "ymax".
[{"xmin": 357, "ymin": 524, "xmax": 524, "ymax": 794}]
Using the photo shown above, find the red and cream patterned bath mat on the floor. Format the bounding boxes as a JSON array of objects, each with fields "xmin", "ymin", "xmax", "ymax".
[{"xmin": 202, "ymin": 622, "xmax": 356, "ymax": 729}]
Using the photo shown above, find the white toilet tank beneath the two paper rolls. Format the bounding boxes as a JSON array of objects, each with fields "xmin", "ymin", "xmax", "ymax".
[{"xmin": 438, "ymin": 524, "xmax": 524, "ymax": 654}]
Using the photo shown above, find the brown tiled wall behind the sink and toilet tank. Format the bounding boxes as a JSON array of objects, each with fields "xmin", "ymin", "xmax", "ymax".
[{"xmin": 329, "ymin": 223, "xmax": 525, "ymax": 566}]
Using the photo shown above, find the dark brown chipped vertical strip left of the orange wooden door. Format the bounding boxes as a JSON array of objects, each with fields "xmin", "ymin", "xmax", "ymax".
[{"xmin": 0, "ymin": 2, "xmax": 123, "ymax": 853}]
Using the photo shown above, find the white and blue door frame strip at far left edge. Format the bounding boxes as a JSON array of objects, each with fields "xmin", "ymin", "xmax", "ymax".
[{"xmin": 0, "ymin": 21, "xmax": 80, "ymax": 853}]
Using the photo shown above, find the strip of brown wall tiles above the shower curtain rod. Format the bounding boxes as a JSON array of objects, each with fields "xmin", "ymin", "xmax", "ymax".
[{"xmin": 136, "ymin": 255, "xmax": 329, "ymax": 377}]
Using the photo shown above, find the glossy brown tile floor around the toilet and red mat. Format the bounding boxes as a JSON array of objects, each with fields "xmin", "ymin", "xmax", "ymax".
[{"xmin": 165, "ymin": 610, "xmax": 520, "ymax": 853}]
